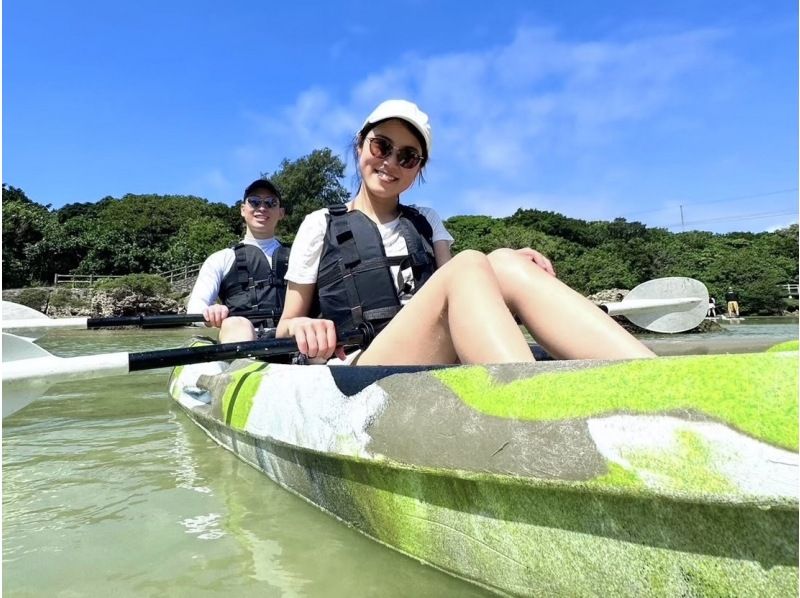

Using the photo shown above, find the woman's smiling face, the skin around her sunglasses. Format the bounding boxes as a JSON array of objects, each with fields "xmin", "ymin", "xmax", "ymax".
[{"xmin": 358, "ymin": 119, "xmax": 424, "ymax": 199}]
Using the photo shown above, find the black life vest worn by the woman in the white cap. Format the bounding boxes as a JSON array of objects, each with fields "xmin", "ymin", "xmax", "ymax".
[{"xmin": 317, "ymin": 205, "xmax": 436, "ymax": 332}]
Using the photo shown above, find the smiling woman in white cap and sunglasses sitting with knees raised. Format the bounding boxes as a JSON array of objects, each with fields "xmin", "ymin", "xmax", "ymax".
[{"xmin": 277, "ymin": 100, "xmax": 653, "ymax": 365}]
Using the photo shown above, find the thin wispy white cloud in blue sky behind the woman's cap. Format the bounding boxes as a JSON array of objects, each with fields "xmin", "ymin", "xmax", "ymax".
[{"xmin": 231, "ymin": 27, "xmax": 726, "ymax": 218}]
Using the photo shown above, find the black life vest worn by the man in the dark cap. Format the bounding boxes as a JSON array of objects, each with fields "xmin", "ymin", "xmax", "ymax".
[{"xmin": 219, "ymin": 243, "xmax": 289, "ymax": 328}]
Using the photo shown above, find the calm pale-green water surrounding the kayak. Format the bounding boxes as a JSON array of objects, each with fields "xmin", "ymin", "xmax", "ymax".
[{"xmin": 2, "ymin": 319, "xmax": 797, "ymax": 597}]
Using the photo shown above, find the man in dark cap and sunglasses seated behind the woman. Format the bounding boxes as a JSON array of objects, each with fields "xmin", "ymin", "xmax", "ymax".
[{"xmin": 186, "ymin": 179, "xmax": 289, "ymax": 343}]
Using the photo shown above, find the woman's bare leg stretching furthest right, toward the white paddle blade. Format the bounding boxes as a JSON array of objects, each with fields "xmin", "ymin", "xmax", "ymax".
[{"xmin": 489, "ymin": 249, "xmax": 654, "ymax": 359}]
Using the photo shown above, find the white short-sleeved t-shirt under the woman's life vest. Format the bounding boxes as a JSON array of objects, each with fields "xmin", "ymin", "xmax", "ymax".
[{"xmin": 286, "ymin": 206, "xmax": 453, "ymax": 301}]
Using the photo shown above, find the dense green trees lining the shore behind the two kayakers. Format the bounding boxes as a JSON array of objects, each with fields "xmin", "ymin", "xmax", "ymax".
[{"xmin": 3, "ymin": 149, "xmax": 798, "ymax": 313}]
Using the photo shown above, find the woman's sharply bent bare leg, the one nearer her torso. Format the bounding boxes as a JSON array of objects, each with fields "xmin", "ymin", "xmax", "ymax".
[{"xmin": 358, "ymin": 251, "xmax": 533, "ymax": 365}]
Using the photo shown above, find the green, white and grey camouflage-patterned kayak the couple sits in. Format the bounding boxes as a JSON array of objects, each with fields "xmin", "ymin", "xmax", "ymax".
[{"xmin": 169, "ymin": 340, "xmax": 798, "ymax": 596}]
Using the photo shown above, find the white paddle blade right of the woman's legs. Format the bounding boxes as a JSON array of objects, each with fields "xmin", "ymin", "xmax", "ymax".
[{"xmin": 619, "ymin": 276, "xmax": 708, "ymax": 334}]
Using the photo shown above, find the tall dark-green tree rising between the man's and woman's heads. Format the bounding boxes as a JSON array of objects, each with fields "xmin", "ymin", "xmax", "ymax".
[{"xmin": 266, "ymin": 148, "xmax": 349, "ymax": 241}]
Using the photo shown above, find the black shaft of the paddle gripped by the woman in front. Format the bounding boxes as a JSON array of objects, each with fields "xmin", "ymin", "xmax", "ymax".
[{"xmin": 128, "ymin": 330, "xmax": 365, "ymax": 372}]
